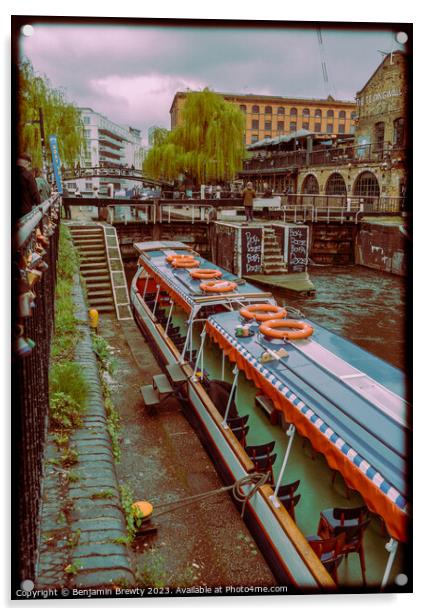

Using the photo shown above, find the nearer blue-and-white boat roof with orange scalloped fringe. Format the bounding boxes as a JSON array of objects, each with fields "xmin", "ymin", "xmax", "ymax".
[{"xmin": 207, "ymin": 311, "xmax": 411, "ymax": 540}]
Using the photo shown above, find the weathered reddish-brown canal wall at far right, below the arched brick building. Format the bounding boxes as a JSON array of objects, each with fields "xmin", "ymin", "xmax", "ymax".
[{"xmin": 355, "ymin": 221, "xmax": 409, "ymax": 276}]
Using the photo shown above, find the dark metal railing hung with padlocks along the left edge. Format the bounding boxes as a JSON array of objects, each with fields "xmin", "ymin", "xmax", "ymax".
[{"xmin": 12, "ymin": 195, "xmax": 60, "ymax": 587}]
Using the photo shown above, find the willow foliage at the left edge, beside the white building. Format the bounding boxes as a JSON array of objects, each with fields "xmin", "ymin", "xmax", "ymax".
[{"xmin": 18, "ymin": 61, "xmax": 85, "ymax": 167}]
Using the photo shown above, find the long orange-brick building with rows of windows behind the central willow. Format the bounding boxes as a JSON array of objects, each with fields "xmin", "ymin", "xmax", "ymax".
[{"xmin": 170, "ymin": 92, "xmax": 357, "ymax": 145}]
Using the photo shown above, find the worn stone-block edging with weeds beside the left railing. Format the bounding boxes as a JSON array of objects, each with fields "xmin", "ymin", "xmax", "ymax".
[{"xmin": 36, "ymin": 277, "xmax": 134, "ymax": 588}]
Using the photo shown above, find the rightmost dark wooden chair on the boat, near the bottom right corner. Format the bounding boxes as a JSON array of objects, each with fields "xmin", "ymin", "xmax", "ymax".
[{"xmin": 317, "ymin": 505, "xmax": 371, "ymax": 585}]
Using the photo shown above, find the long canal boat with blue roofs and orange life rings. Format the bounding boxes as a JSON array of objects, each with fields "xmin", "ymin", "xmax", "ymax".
[{"xmin": 130, "ymin": 241, "xmax": 411, "ymax": 592}]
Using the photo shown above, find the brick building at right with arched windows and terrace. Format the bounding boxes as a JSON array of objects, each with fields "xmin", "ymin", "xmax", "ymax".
[{"xmin": 240, "ymin": 52, "xmax": 408, "ymax": 209}]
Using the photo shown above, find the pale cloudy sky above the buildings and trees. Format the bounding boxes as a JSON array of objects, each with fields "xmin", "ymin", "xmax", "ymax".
[{"xmin": 20, "ymin": 22, "xmax": 403, "ymax": 141}]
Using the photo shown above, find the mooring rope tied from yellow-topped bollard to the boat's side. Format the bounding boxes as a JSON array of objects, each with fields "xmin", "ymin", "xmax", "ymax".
[{"xmin": 147, "ymin": 472, "xmax": 270, "ymax": 519}]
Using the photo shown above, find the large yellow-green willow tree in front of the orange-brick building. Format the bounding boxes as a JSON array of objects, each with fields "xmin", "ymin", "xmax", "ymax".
[{"xmin": 144, "ymin": 88, "xmax": 245, "ymax": 184}]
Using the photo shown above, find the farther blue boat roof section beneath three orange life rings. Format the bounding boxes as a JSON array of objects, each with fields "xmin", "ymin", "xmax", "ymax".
[{"xmin": 134, "ymin": 241, "xmax": 274, "ymax": 314}]
